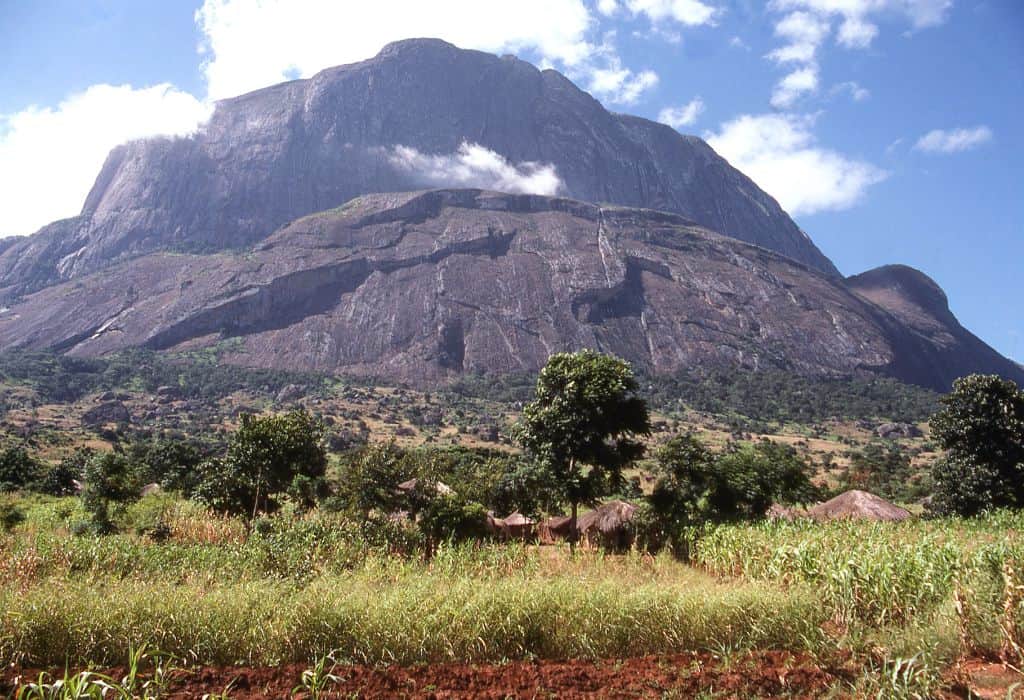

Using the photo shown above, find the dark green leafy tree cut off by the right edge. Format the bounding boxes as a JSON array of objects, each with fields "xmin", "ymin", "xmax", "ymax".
[{"xmin": 932, "ymin": 375, "xmax": 1024, "ymax": 516}]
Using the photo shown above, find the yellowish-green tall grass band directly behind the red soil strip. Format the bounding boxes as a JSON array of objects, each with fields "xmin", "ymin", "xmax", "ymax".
[{"xmin": 0, "ymin": 551, "xmax": 823, "ymax": 665}]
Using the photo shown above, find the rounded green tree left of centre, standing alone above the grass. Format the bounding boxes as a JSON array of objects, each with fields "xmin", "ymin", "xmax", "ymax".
[{"xmin": 195, "ymin": 410, "xmax": 327, "ymax": 517}]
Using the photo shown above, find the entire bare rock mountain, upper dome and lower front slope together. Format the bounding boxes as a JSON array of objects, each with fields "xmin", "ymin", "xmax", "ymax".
[{"xmin": 0, "ymin": 40, "xmax": 1024, "ymax": 390}]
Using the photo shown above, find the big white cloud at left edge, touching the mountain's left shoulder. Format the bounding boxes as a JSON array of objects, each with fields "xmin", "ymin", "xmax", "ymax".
[{"xmin": 0, "ymin": 83, "xmax": 209, "ymax": 234}]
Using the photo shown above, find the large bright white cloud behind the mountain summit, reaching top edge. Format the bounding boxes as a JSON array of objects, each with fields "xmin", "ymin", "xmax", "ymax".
[{"xmin": 196, "ymin": 0, "xmax": 595, "ymax": 98}]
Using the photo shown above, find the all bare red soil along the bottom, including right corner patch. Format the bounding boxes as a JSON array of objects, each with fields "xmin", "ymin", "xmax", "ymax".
[{"xmin": 8, "ymin": 651, "xmax": 1024, "ymax": 700}]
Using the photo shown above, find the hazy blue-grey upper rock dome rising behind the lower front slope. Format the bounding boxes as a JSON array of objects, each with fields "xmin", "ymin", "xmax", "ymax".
[{"xmin": 0, "ymin": 39, "xmax": 839, "ymax": 301}]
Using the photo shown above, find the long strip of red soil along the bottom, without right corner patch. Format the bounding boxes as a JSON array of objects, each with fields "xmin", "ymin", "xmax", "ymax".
[{"xmin": 0, "ymin": 651, "xmax": 839, "ymax": 700}]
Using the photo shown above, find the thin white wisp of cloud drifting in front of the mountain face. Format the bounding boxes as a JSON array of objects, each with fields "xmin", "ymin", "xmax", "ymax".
[{"xmin": 388, "ymin": 142, "xmax": 563, "ymax": 195}]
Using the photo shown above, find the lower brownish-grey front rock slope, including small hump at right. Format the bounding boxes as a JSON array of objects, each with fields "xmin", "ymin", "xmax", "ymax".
[{"xmin": 0, "ymin": 189, "xmax": 1024, "ymax": 389}]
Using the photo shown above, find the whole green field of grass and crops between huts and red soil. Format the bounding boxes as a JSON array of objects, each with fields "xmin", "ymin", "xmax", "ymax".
[{"xmin": 0, "ymin": 496, "xmax": 1024, "ymax": 697}]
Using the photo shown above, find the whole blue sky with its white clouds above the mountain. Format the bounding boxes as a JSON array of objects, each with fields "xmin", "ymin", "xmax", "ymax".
[{"xmin": 0, "ymin": 0, "xmax": 1024, "ymax": 361}]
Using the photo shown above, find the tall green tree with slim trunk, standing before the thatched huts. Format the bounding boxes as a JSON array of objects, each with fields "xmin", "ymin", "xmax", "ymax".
[{"xmin": 516, "ymin": 350, "xmax": 650, "ymax": 546}]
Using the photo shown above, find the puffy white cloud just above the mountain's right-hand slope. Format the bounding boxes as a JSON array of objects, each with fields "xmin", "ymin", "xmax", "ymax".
[{"xmin": 706, "ymin": 115, "xmax": 888, "ymax": 216}]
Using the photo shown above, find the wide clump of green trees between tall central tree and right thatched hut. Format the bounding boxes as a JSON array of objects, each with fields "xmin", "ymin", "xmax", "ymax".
[{"xmin": 646, "ymin": 435, "xmax": 816, "ymax": 549}]
